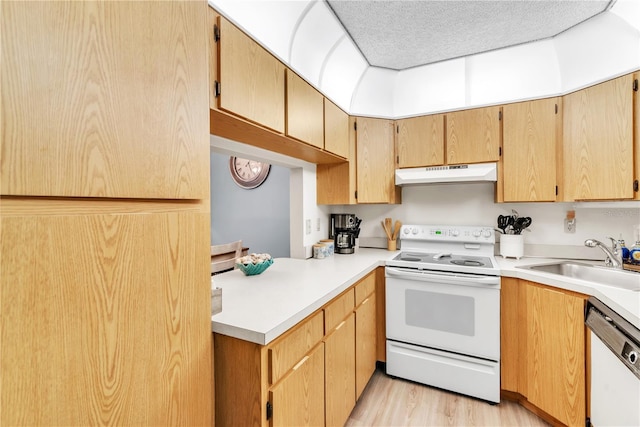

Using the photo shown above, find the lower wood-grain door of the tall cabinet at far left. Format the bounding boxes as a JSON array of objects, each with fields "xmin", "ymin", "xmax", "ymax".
[{"xmin": 0, "ymin": 213, "xmax": 212, "ymax": 426}]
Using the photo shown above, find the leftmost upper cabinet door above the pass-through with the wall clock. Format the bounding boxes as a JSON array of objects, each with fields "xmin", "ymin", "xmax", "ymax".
[{"xmin": 218, "ymin": 17, "xmax": 285, "ymax": 133}]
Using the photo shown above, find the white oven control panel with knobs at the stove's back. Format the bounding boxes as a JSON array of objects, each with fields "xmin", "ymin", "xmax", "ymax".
[{"xmin": 400, "ymin": 225, "xmax": 496, "ymax": 243}]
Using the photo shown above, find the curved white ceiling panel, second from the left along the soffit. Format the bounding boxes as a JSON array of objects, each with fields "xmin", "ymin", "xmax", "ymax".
[{"xmin": 290, "ymin": 2, "xmax": 345, "ymax": 86}]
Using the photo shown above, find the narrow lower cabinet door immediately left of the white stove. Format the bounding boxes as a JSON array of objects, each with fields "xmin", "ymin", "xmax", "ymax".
[{"xmin": 356, "ymin": 293, "xmax": 376, "ymax": 400}]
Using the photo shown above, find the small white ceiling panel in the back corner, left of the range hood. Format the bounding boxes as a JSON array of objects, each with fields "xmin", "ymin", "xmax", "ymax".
[{"xmin": 349, "ymin": 67, "xmax": 398, "ymax": 118}]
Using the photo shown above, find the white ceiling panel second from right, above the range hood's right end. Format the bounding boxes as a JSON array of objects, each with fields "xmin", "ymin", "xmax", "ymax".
[{"xmin": 465, "ymin": 39, "xmax": 561, "ymax": 107}]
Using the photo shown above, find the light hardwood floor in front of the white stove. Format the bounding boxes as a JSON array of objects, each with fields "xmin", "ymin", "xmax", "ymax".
[{"xmin": 346, "ymin": 369, "xmax": 549, "ymax": 427}]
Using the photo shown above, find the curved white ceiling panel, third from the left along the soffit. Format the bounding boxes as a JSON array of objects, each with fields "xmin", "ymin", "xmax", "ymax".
[{"xmin": 318, "ymin": 35, "xmax": 368, "ymax": 111}]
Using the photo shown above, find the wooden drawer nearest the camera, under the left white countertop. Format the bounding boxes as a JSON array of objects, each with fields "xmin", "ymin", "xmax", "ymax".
[{"xmin": 269, "ymin": 311, "xmax": 324, "ymax": 384}]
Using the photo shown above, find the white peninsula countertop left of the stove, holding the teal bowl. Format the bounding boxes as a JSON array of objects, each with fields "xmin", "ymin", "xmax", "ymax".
[{"xmin": 211, "ymin": 248, "xmax": 399, "ymax": 345}]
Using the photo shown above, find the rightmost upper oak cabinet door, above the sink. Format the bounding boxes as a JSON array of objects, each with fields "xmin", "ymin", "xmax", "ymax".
[{"xmin": 563, "ymin": 75, "xmax": 634, "ymax": 201}]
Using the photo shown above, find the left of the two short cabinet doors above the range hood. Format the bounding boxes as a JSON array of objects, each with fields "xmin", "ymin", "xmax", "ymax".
[{"xmin": 396, "ymin": 114, "xmax": 444, "ymax": 168}]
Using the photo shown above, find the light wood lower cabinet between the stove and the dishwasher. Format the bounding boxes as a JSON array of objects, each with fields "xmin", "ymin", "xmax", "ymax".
[{"xmin": 501, "ymin": 278, "xmax": 587, "ymax": 426}]
